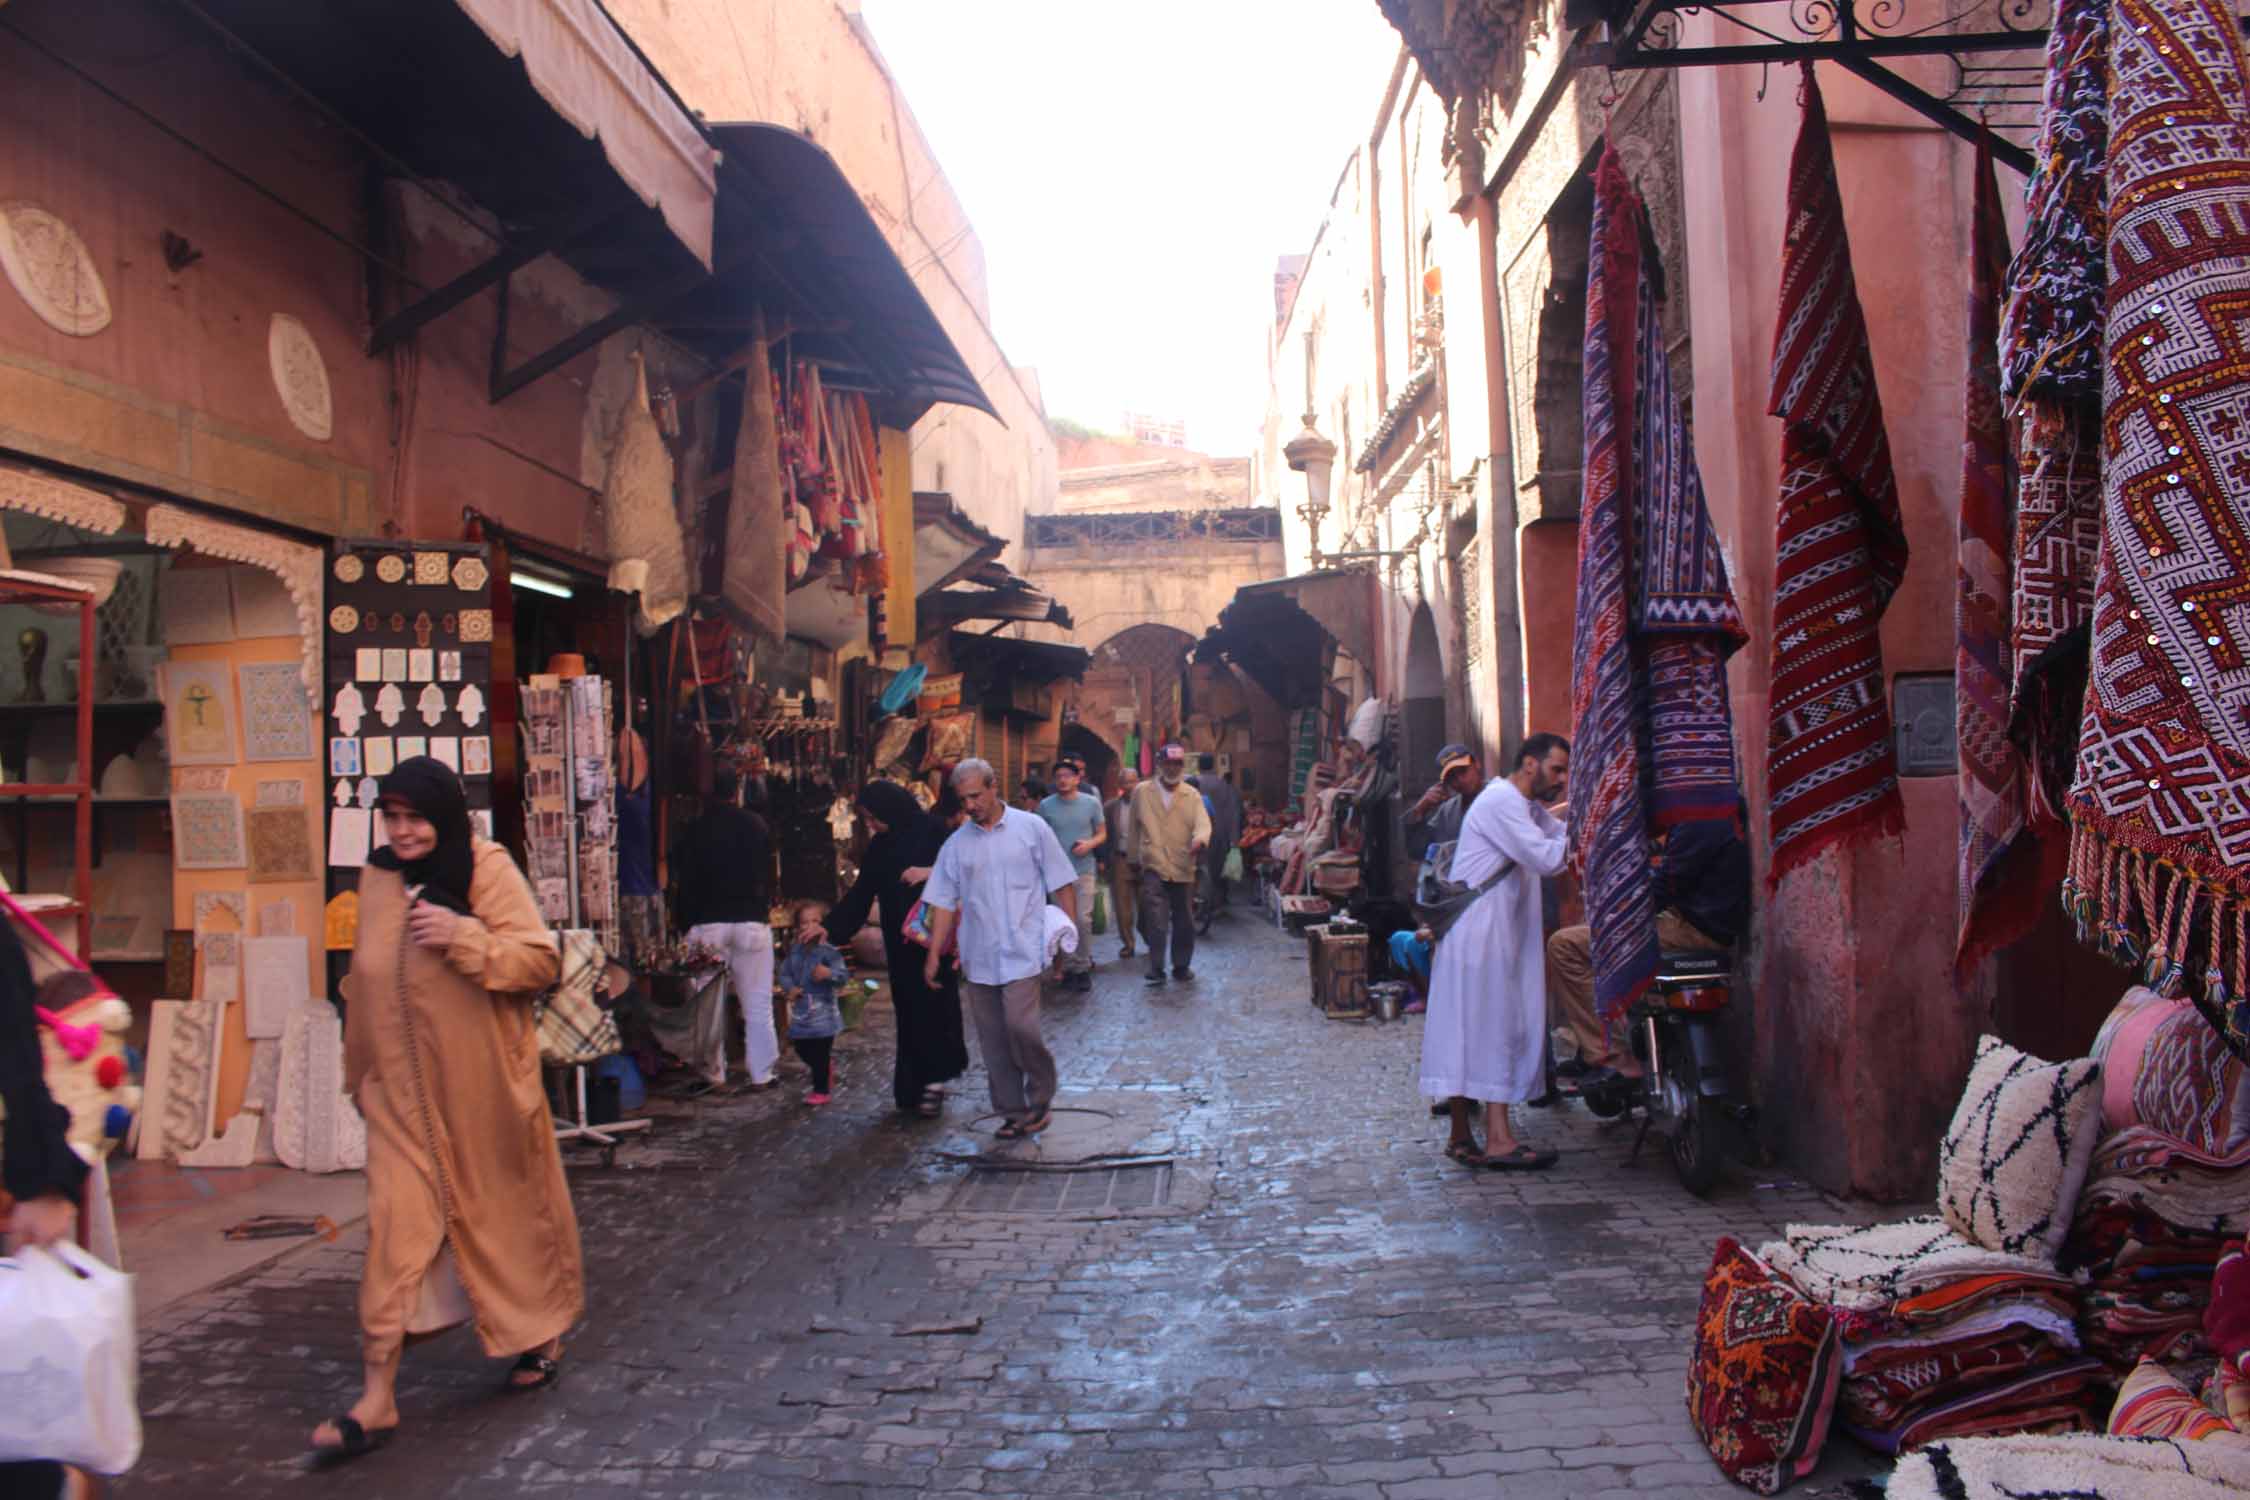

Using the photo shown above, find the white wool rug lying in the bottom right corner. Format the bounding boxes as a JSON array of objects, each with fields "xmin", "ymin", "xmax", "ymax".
[{"xmin": 1883, "ymin": 1437, "xmax": 2250, "ymax": 1500}]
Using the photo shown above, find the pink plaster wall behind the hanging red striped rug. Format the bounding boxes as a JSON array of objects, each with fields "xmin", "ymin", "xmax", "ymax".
[{"xmin": 1681, "ymin": 67, "xmax": 1989, "ymax": 1199}]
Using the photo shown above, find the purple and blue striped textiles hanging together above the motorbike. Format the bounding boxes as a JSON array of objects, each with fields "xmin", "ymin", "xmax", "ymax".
[{"xmin": 1571, "ymin": 146, "xmax": 1744, "ymax": 1014}]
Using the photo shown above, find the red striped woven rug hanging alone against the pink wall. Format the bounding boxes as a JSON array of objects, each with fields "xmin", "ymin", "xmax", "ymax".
[{"xmin": 1766, "ymin": 63, "xmax": 1906, "ymax": 884}]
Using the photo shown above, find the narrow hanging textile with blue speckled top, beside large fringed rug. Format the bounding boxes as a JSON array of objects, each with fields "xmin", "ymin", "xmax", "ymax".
[{"xmin": 2000, "ymin": 0, "xmax": 2111, "ymax": 843}]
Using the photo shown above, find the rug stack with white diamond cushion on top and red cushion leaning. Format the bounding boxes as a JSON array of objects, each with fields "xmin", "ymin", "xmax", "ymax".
[{"xmin": 1688, "ymin": 1037, "xmax": 2108, "ymax": 1493}]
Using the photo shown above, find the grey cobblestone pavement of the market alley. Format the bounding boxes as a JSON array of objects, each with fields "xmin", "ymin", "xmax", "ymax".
[{"xmin": 119, "ymin": 913, "xmax": 1872, "ymax": 1500}]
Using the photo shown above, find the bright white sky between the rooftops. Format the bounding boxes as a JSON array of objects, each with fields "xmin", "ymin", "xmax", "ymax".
[{"xmin": 862, "ymin": 0, "xmax": 1400, "ymax": 454}]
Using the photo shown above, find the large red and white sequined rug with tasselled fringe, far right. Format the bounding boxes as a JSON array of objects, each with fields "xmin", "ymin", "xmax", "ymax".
[{"xmin": 2068, "ymin": 0, "xmax": 2250, "ymax": 1057}]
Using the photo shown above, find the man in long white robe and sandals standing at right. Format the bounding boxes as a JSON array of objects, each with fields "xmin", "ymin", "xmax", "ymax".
[{"xmin": 1422, "ymin": 733, "xmax": 1571, "ymax": 1172}]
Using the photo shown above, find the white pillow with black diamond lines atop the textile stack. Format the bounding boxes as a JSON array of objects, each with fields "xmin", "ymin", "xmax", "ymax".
[{"xmin": 1937, "ymin": 1037, "xmax": 2102, "ymax": 1259}]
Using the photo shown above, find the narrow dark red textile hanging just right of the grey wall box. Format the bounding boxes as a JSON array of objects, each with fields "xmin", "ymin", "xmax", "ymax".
[{"xmin": 1953, "ymin": 135, "xmax": 2063, "ymax": 983}]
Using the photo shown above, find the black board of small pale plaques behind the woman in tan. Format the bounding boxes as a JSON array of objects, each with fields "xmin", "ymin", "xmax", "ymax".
[{"xmin": 321, "ymin": 542, "xmax": 493, "ymax": 998}]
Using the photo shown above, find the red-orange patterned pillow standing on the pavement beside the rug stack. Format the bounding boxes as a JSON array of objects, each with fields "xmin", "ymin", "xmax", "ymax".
[{"xmin": 1688, "ymin": 1239, "xmax": 1843, "ymax": 1496}]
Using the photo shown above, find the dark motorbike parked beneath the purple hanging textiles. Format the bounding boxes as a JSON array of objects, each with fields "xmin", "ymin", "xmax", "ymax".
[{"xmin": 1580, "ymin": 951, "xmax": 1755, "ymax": 1196}]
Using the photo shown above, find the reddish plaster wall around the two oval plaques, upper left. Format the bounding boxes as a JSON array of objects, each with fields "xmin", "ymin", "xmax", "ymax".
[{"xmin": 0, "ymin": 0, "xmax": 601, "ymax": 551}]
